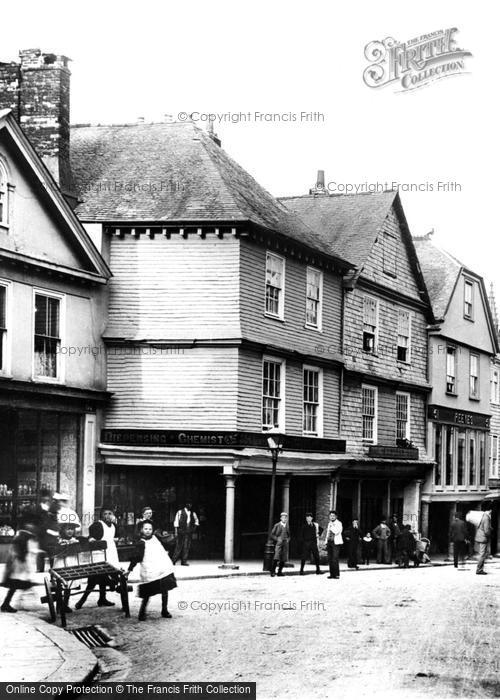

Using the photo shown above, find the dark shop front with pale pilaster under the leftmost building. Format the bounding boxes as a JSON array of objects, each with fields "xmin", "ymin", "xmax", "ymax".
[{"xmin": 0, "ymin": 383, "xmax": 104, "ymax": 549}]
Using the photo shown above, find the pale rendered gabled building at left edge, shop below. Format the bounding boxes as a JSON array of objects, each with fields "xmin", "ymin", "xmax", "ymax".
[{"xmin": 0, "ymin": 105, "xmax": 110, "ymax": 536}]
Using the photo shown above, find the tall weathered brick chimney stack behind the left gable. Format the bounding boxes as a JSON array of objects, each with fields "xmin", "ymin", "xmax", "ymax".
[{"xmin": 0, "ymin": 49, "xmax": 76, "ymax": 205}]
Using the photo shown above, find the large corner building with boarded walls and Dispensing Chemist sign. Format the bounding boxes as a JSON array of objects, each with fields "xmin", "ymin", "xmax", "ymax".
[{"xmin": 71, "ymin": 123, "xmax": 352, "ymax": 563}]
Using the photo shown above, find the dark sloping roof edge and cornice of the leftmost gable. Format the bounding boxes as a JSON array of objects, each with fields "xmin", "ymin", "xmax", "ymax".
[{"xmin": 0, "ymin": 109, "xmax": 111, "ymax": 282}]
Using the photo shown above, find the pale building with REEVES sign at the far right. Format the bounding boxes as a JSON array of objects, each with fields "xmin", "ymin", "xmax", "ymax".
[{"xmin": 415, "ymin": 234, "xmax": 498, "ymax": 551}]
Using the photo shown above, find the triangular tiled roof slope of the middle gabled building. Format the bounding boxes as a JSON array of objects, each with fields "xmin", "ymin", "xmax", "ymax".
[{"xmin": 280, "ymin": 191, "xmax": 396, "ymax": 269}]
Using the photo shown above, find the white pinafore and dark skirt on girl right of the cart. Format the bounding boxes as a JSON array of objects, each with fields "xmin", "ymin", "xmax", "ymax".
[{"xmin": 129, "ymin": 535, "xmax": 177, "ymax": 598}]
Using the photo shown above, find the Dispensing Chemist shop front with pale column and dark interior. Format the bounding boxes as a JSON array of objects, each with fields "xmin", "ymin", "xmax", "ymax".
[{"xmin": 95, "ymin": 429, "xmax": 345, "ymax": 565}]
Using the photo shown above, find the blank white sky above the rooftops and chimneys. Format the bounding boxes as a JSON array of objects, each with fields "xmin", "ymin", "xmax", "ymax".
[{"xmin": 0, "ymin": 0, "xmax": 500, "ymax": 294}]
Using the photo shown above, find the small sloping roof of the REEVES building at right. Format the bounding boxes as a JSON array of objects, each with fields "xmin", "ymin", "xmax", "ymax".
[{"xmin": 413, "ymin": 236, "xmax": 464, "ymax": 320}]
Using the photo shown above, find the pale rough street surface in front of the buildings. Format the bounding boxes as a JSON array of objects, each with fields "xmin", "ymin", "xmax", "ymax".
[{"xmin": 25, "ymin": 561, "xmax": 500, "ymax": 699}]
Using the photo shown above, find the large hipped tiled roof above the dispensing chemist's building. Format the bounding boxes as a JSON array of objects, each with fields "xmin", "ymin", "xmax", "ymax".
[{"xmin": 71, "ymin": 122, "xmax": 350, "ymax": 268}]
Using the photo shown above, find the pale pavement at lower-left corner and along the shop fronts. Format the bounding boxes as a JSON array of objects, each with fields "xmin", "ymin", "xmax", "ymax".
[{"xmin": 0, "ymin": 555, "xmax": 498, "ymax": 683}]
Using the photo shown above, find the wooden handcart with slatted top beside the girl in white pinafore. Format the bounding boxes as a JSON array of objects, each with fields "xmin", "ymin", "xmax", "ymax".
[{"xmin": 41, "ymin": 541, "xmax": 131, "ymax": 627}]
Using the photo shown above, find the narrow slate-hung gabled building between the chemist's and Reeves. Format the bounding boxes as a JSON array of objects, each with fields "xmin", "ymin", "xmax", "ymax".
[{"xmin": 282, "ymin": 188, "xmax": 432, "ymax": 531}]
